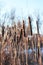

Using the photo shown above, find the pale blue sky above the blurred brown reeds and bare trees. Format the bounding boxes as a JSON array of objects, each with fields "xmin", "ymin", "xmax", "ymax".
[{"xmin": 0, "ymin": 0, "xmax": 43, "ymax": 34}]
